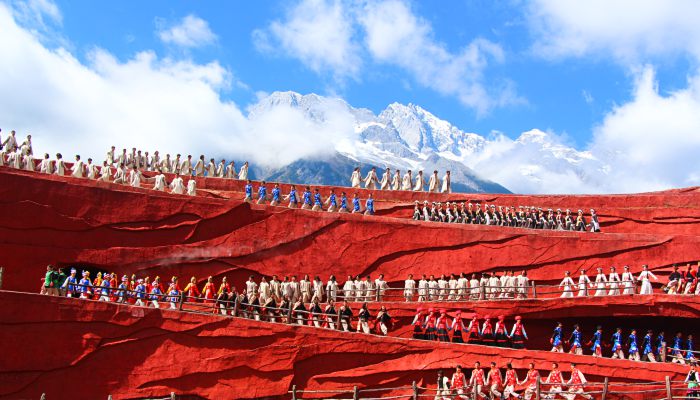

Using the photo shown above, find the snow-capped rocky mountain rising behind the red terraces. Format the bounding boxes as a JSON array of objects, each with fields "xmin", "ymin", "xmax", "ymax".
[{"xmin": 249, "ymin": 92, "xmax": 605, "ymax": 193}]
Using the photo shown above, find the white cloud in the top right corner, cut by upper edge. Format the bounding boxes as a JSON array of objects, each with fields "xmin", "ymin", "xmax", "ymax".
[{"xmin": 528, "ymin": 0, "xmax": 700, "ymax": 64}]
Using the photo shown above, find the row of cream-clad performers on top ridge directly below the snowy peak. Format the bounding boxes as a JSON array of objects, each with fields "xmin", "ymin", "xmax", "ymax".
[{"xmin": 350, "ymin": 167, "xmax": 452, "ymax": 193}]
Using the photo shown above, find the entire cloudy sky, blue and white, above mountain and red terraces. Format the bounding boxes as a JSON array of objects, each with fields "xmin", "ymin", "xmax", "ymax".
[{"xmin": 0, "ymin": 0, "xmax": 700, "ymax": 193}]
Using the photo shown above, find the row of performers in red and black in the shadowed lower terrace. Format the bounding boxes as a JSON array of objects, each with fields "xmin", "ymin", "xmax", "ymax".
[{"xmin": 412, "ymin": 307, "xmax": 527, "ymax": 349}]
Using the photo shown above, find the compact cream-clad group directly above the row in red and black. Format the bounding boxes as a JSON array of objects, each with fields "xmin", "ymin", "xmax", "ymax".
[{"xmin": 403, "ymin": 270, "xmax": 530, "ymax": 302}]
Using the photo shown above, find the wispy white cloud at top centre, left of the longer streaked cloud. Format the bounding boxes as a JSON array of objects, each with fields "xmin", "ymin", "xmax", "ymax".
[{"xmin": 253, "ymin": 0, "xmax": 362, "ymax": 80}]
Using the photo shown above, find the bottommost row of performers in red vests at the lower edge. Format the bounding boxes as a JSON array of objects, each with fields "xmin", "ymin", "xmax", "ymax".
[{"xmin": 435, "ymin": 361, "xmax": 593, "ymax": 400}]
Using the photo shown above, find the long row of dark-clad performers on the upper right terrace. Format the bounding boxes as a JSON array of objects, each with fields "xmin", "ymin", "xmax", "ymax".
[{"xmin": 413, "ymin": 200, "xmax": 600, "ymax": 232}]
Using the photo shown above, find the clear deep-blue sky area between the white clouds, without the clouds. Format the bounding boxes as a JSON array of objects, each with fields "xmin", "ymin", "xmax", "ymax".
[{"xmin": 45, "ymin": 0, "xmax": 688, "ymax": 146}]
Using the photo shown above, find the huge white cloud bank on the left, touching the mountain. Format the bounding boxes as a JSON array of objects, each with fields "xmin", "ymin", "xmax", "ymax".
[{"xmin": 0, "ymin": 3, "xmax": 346, "ymax": 167}]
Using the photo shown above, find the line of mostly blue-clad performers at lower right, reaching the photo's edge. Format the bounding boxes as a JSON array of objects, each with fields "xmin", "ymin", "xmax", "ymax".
[{"xmin": 549, "ymin": 323, "xmax": 697, "ymax": 364}]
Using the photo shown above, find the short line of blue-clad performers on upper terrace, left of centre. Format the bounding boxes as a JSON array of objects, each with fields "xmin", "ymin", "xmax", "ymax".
[{"xmin": 243, "ymin": 180, "xmax": 374, "ymax": 215}]
